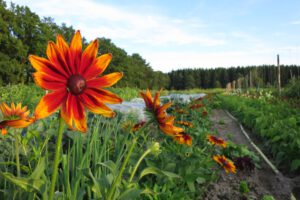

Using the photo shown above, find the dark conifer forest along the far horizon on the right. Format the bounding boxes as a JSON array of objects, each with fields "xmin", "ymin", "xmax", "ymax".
[{"xmin": 168, "ymin": 65, "xmax": 300, "ymax": 90}]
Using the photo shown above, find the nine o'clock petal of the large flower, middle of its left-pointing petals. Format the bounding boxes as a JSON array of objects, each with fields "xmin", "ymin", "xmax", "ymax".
[{"xmin": 33, "ymin": 72, "xmax": 67, "ymax": 90}]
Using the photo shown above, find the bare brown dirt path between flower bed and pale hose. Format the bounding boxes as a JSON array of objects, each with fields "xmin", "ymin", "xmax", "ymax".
[{"xmin": 205, "ymin": 110, "xmax": 291, "ymax": 200}]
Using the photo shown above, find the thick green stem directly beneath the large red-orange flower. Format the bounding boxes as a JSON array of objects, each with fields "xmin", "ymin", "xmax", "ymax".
[{"xmin": 49, "ymin": 117, "xmax": 64, "ymax": 200}]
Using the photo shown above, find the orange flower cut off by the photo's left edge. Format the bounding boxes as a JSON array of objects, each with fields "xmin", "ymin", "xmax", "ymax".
[{"xmin": 0, "ymin": 103, "xmax": 35, "ymax": 135}]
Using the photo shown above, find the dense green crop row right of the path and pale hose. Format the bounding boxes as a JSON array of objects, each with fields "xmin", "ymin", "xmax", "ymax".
[{"xmin": 219, "ymin": 95, "xmax": 300, "ymax": 171}]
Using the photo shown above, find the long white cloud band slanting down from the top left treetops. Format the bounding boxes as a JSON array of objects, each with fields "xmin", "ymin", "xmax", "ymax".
[{"xmin": 10, "ymin": 0, "xmax": 225, "ymax": 46}]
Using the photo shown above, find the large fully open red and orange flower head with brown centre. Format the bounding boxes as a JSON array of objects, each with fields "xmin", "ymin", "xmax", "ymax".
[{"xmin": 29, "ymin": 31, "xmax": 123, "ymax": 132}]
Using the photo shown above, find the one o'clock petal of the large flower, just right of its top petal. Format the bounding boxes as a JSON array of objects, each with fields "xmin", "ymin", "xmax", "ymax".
[{"xmin": 79, "ymin": 40, "xmax": 98, "ymax": 74}]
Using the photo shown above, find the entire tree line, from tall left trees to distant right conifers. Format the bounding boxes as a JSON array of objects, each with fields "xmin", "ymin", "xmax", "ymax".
[{"xmin": 0, "ymin": 0, "xmax": 300, "ymax": 89}]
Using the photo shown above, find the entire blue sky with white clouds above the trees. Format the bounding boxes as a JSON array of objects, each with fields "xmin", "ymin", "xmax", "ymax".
[{"xmin": 8, "ymin": 0, "xmax": 300, "ymax": 72}]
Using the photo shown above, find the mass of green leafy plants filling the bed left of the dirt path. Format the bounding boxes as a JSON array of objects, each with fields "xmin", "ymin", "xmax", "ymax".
[{"xmin": 0, "ymin": 90, "xmax": 223, "ymax": 199}]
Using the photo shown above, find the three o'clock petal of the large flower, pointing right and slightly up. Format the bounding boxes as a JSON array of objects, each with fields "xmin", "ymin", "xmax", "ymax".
[{"xmin": 86, "ymin": 72, "xmax": 123, "ymax": 88}]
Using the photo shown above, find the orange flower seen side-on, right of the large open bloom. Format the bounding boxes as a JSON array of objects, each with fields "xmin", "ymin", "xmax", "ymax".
[{"xmin": 140, "ymin": 89, "xmax": 183, "ymax": 136}]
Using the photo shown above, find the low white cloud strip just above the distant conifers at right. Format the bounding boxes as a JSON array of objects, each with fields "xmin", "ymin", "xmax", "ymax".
[{"xmin": 145, "ymin": 47, "xmax": 300, "ymax": 72}]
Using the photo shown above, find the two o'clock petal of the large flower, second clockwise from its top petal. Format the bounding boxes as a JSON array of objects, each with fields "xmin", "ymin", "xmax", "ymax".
[{"xmin": 83, "ymin": 54, "xmax": 112, "ymax": 80}]
